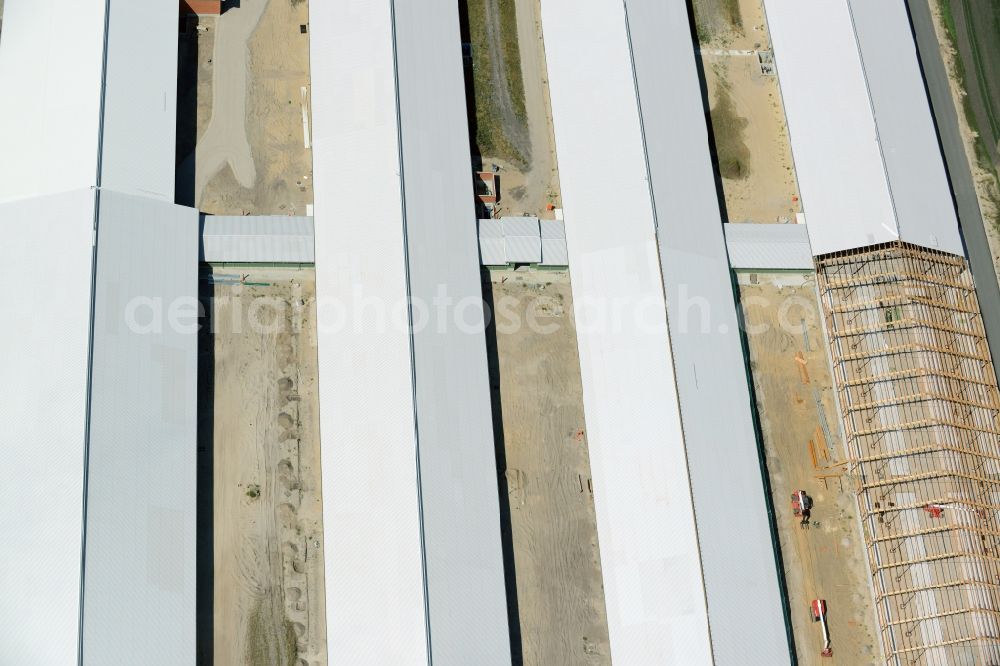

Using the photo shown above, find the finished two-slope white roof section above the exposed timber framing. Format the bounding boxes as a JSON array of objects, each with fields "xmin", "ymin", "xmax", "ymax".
[{"xmin": 764, "ymin": 0, "xmax": 963, "ymax": 254}]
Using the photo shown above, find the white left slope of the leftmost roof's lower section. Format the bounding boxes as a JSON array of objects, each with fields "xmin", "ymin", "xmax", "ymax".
[{"xmin": 0, "ymin": 187, "xmax": 94, "ymax": 664}]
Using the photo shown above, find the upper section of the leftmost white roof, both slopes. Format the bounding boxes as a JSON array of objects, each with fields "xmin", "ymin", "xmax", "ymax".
[{"xmin": 0, "ymin": 0, "xmax": 177, "ymax": 201}]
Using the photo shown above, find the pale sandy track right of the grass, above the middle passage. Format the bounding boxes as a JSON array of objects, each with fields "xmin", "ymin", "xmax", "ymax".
[{"xmin": 483, "ymin": 0, "xmax": 561, "ymax": 219}]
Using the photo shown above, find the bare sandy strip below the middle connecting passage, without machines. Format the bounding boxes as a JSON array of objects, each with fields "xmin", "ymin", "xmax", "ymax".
[{"xmin": 484, "ymin": 271, "xmax": 611, "ymax": 666}]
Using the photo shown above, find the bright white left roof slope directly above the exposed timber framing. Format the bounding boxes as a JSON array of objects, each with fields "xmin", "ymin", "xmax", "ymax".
[{"xmin": 764, "ymin": 0, "xmax": 899, "ymax": 254}]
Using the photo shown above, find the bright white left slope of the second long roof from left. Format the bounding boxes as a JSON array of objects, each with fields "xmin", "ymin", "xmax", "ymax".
[{"xmin": 309, "ymin": 2, "xmax": 426, "ymax": 666}]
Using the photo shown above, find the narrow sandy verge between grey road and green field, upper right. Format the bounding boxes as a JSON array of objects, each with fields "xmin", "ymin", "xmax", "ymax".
[{"xmin": 928, "ymin": 0, "xmax": 1000, "ymax": 279}]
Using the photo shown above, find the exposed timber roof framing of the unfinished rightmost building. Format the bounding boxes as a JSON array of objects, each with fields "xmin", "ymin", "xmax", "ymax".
[{"xmin": 816, "ymin": 242, "xmax": 1000, "ymax": 666}]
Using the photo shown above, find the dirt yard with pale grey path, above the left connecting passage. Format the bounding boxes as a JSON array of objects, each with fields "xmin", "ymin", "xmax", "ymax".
[{"xmin": 179, "ymin": 0, "xmax": 312, "ymax": 215}]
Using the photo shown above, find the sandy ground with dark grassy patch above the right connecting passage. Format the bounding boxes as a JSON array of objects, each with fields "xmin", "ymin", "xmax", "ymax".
[{"xmin": 695, "ymin": 0, "xmax": 802, "ymax": 223}]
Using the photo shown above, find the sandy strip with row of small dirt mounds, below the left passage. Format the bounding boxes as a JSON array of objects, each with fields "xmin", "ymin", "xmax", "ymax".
[{"xmin": 213, "ymin": 269, "xmax": 326, "ymax": 666}]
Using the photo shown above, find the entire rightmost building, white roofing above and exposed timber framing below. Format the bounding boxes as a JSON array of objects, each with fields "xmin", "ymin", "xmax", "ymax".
[{"xmin": 764, "ymin": 0, "xmax": 1000, "ymax": 666}]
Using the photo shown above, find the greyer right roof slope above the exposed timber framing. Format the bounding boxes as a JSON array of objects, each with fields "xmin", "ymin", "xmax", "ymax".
[{"xmin": 850, "ymin": 0, "xmax": 965, "ymax": 255}]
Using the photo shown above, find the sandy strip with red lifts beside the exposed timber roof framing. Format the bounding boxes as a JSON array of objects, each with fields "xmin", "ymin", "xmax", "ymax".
[{"xmin": 739, "ymin": 273, "xmax": 881, "ymax": 666}]
